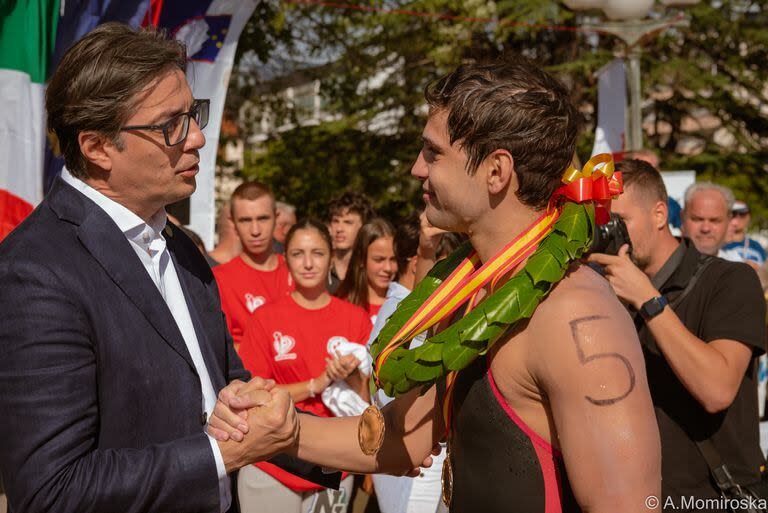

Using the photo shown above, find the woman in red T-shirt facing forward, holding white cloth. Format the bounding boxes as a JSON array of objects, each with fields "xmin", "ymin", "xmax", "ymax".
[{"xmin": 238, "ymin": 220, "xmax": 372, "ymax": 513}]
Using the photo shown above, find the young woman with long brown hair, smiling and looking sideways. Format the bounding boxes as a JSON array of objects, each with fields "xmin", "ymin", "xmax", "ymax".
[{"xmin": 336, "ymin": 218, "xmax": 397, "ymax": 323}]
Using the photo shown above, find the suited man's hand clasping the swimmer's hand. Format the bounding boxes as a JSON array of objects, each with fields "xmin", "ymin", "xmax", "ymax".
[{"xmin": 219, "ymin": 388, "xmax": 299, "ymax": 472}]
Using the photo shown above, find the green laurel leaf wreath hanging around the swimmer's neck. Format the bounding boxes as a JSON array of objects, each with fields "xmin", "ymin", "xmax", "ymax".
[{"xmin": 371, "ymin": 201, "xmax": 595, "ymax": 397}]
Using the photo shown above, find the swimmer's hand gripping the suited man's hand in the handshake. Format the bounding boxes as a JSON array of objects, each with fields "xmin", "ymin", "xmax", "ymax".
[{"xmin": 208, "ymin": 377, "xmax": 275, "ymax": 442}]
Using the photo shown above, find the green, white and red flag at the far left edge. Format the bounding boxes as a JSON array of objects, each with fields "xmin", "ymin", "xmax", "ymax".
[{"xmin": 0, "ymin": 0, "xmax": 60, "ymax": 240}]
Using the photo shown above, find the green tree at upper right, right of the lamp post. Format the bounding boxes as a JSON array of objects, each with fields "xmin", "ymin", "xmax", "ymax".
[{"xmin": 643, "ymin": 0, "xmax": 768, "ymax": 222}]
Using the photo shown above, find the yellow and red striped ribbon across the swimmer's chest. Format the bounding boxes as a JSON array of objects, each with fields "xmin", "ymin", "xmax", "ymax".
[{"xmin": 373, "ymin": 208, "xmax": 560, "ymax": 382}]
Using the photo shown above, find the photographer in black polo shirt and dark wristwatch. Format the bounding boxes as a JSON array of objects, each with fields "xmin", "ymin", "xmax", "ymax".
[{"xmin": 589, "ymin": 160, "xmax": 765, "ymax": 509}]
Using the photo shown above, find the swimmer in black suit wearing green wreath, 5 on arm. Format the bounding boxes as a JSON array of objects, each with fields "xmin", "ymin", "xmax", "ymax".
[{"xmin": 211, "ymin": 58, "xmax": 661, "ymax": 513}]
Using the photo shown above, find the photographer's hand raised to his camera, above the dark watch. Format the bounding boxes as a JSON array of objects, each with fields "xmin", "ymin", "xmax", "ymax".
[{"xmin": 587, "ymin": 244, "xmax": 659, "ymax": 310}]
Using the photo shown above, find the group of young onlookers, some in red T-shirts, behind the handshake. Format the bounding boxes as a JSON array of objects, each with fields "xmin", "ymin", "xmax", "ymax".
[{"xmin": 202, "ymin": 181, "xmax": 466, "ymax": 513}]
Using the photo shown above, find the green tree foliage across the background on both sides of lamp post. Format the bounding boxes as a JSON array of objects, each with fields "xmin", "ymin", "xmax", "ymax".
[{"xmin": 230, "ymin": 0, "xmax": 768, "ymax": 224}]
